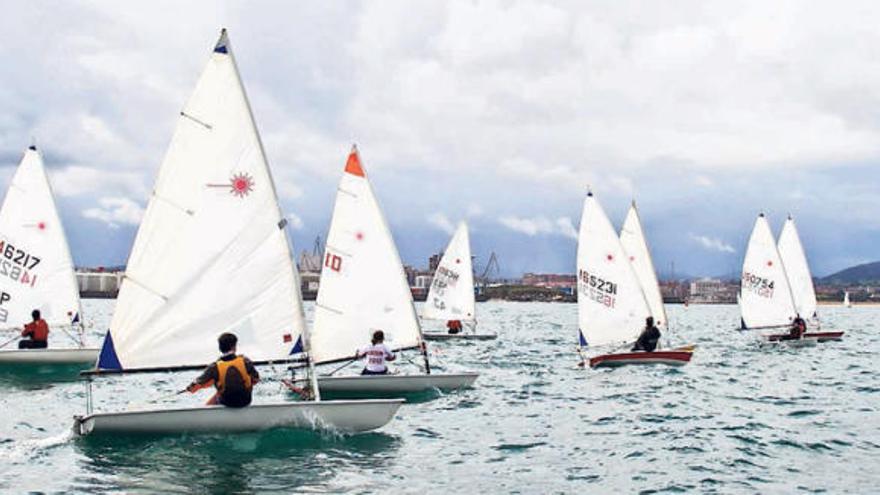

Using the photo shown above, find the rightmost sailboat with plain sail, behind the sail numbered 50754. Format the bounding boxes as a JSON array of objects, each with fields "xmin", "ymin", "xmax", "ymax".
[{"xmin": 777, "ymin": 215, "xmax": 844, "ymax": 342}]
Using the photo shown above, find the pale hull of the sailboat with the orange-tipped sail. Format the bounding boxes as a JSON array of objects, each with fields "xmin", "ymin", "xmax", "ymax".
[{"xmin": 306, "ymin": 373, "xmax": 480, "ymax": 394}]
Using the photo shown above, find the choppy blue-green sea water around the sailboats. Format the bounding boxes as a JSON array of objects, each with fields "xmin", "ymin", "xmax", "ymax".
[{"xmin": 0, "ymin": 301, "xmax": 880, "ymax": 493}]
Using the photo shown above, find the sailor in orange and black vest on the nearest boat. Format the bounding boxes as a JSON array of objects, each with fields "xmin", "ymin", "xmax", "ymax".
[{"xmin": 186, "ymin": 333, "xmax": 260, "ymax": 407}]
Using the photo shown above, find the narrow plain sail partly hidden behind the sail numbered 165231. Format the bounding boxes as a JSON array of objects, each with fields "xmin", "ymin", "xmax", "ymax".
[{"xmin": 620, "ymin": 201, "xmax": 667, "ymax": 331}]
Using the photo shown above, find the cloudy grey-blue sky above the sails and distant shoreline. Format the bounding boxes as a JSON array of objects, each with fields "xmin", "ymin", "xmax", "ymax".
[{"xmin": 0, "ymin": 0, "xmax": 880, "ymax": 275}]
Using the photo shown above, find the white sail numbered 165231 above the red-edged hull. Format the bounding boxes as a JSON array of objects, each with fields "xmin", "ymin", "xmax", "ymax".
[{"xmin": 577, "ymin": 193, "xmax": 651, "ymax": 346}]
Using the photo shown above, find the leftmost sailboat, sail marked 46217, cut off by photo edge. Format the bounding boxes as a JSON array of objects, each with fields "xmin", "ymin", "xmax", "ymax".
[{"xmin": 0, "ymin": 146, "xmax": 98, "ymax": 364}]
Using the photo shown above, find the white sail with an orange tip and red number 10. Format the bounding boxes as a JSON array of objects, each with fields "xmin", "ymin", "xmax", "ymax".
[{"xmin": 310, "ymin": 148, "xmax": 421, "ymax": 364}]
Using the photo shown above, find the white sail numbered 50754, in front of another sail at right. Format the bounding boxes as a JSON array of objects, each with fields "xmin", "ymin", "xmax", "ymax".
[{"xmin": 740, "ymin": 213, "xmax": 797, "ymax": 328}]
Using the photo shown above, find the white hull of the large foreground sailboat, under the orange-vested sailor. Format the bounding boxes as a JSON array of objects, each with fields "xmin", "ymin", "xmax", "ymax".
[{"xmin": 74, "ymin": 399, "xmax": 403, "ymax": 435}]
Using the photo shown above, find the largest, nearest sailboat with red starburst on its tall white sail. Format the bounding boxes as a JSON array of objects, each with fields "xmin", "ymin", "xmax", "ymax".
[{"xmin": 74, "ymin": 30, "xmax": 402, "ymax": 435}]
